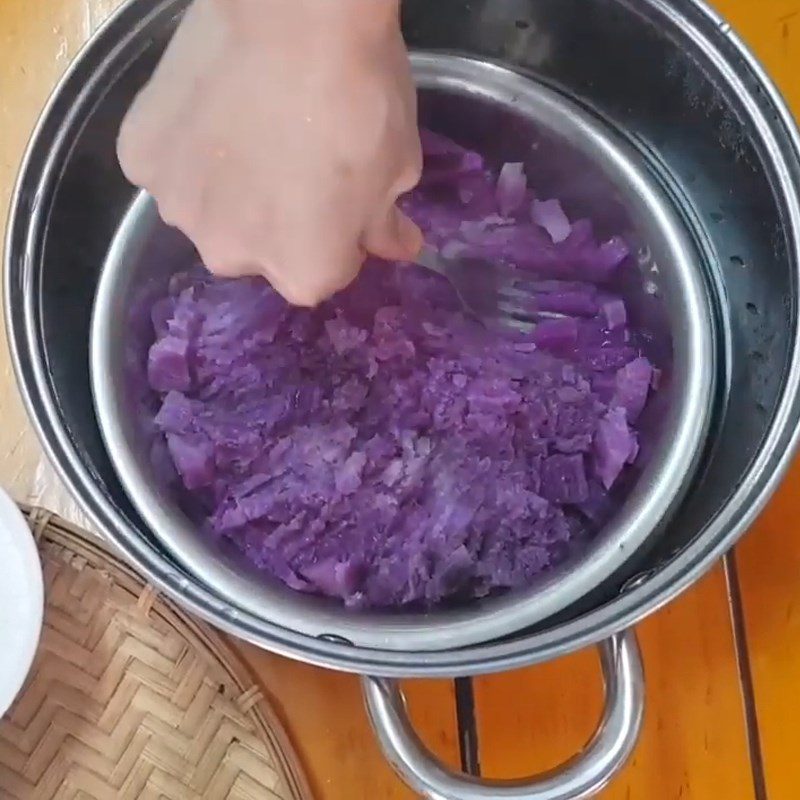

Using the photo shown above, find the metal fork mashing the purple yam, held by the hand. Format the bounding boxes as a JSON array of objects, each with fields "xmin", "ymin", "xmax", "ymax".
[{"xmin": 415, "ymin": 244, "xmax": 565, "ymax": 332}]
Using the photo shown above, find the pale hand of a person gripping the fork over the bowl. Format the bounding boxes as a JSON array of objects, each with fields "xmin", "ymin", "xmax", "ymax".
[{"xmin": 118, "ymin": 0, "xmax": 422, "ymax": 306}]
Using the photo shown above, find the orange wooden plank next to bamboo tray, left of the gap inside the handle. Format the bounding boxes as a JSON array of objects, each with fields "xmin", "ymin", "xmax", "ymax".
[{"xmin": 234, "ymin": 645, "xmax": 459, "ymax": 800}]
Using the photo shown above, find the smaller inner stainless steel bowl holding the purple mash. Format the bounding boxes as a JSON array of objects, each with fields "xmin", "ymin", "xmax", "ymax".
[{"xmin": 90, "ymin": 54, "xmax": 714, "ymax": 651}]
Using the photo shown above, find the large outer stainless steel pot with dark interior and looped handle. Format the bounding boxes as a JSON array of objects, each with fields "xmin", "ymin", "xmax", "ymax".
[{"xmin": 6, "ymin": 0, "xmax": 800, "ymax": 798}]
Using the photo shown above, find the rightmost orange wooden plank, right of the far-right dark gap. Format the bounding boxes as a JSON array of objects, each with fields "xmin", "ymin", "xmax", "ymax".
[{"xmin": 717, "ymin": 0, "xmax": 800, "ymax": 800}]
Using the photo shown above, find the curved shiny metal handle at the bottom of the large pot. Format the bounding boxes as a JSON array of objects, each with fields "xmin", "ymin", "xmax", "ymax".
[{"xmin": 362, "ymin": 630, "xmax": 644, "ymax": 800}]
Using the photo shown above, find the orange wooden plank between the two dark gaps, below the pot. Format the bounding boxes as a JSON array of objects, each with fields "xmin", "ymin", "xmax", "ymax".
[{"xmin": 475, "ymin": 568, "xmax": 754, "ymax": 800}]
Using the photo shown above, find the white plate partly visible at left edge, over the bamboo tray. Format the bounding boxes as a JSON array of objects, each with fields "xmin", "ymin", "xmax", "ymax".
[{"xmin": 0, "ymin": 491, "xmax": 44, "ymax": 716}]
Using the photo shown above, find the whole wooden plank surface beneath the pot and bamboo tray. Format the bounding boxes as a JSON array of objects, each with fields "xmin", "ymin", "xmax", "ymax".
[{"xmin": 0, "ymin": 0, "xmax": 800, "ymax": 800}]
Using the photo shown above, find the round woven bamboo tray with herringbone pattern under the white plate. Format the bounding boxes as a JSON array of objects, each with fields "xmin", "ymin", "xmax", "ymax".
[{"xmin": 0, "ymin": 509, "xmax": 318, "ymax": 800}]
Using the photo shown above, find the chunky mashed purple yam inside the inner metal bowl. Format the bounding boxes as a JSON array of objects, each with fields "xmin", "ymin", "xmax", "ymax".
[{"xmin": 148, "ymin": 133, "xmax": 656, "ymax": 608}]
